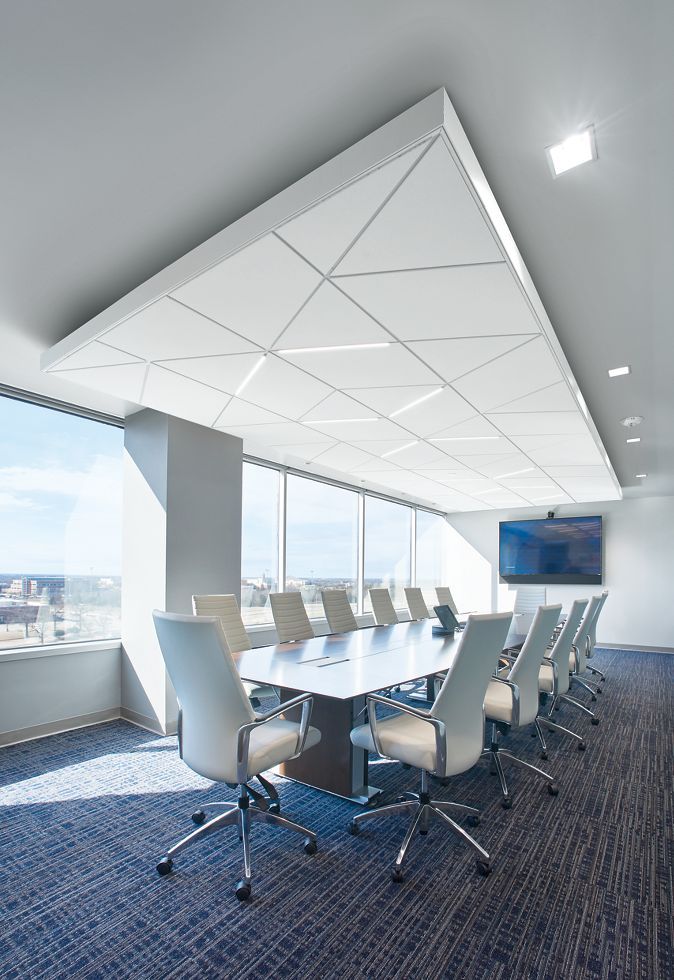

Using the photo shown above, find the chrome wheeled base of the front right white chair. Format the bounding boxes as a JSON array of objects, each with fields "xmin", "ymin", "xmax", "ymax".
[{"xmin": 349, "ymin": 771, "xmax": 491, "ymax": 882}]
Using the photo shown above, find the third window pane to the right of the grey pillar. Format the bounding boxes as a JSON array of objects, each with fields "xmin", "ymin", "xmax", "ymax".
[{"xmin": 364, "ymin": 497, "xmax": 412, "ymax": 610}]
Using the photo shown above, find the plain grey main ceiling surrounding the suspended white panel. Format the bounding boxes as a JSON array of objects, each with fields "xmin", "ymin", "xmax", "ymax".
[{"xmin": 0, "ymin": 0, "xmax": 674, "ymax": 498}]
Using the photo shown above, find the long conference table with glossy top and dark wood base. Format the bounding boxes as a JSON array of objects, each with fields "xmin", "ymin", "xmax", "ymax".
[{"xmin": 235, "ymin": 620, "xmax": 518, "ymax": 803}]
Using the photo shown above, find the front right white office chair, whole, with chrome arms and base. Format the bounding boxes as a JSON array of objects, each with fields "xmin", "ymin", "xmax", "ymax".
[{"xmin": 349, "ymin": 612, "xmax": 512, "ymax": 881}]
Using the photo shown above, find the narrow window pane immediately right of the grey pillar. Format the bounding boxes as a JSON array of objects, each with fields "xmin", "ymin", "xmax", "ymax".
[{"xmin": 241, "ymin": 463, "xmax": 281, "ymax": 625}]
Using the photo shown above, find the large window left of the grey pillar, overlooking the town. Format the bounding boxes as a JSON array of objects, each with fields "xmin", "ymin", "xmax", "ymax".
[{"xmin": 0, "ymin": 396, "xmax": 124, "ymax": 650}]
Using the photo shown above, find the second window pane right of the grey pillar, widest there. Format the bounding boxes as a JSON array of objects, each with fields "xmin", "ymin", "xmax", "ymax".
[{"xmin": 286, "ymin": 475, "xmax": 358, "ymax": 619}]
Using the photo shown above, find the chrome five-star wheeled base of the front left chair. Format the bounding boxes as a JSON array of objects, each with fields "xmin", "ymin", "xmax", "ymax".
[{"xmin": 157, "ymin": 784, "xmax": 318, "ymax": 901}]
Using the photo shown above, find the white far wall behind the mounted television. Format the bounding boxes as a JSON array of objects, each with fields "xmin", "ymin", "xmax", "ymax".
[{"xmin": 448, "ymin": 497, "xmax": 674, "ymax": 648}]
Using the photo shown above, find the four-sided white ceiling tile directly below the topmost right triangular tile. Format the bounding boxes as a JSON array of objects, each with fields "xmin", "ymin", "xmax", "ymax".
[{"xmin": 335, "ymin": 263, "xmax": 540, "ymax": 340}]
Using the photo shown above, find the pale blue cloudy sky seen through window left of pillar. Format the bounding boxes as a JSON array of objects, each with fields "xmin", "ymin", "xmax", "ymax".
[{"xmin": 0, "ymin": 396, "xmax": 124, "ymax": 576}]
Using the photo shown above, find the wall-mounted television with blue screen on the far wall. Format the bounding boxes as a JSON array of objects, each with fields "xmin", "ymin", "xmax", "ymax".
[{"xmin": 499, "ymin": 517, "xmax": 602, "ymax": 585}]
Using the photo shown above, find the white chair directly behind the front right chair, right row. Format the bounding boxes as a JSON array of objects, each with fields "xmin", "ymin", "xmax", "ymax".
[{"xmin": 483, "ymin": 604, "xmax": 562, "ymax": 810}]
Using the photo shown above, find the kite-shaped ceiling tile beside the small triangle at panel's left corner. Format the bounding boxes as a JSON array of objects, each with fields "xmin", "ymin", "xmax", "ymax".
[{"xmin": 102, "ymin": 296, "xmax": 257, "ymax": 361}]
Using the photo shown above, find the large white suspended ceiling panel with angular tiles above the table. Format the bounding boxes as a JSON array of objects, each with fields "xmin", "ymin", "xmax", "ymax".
[{"xmin": 43, "ymin": 90, "xmax": 621, "ymax": 511}]
